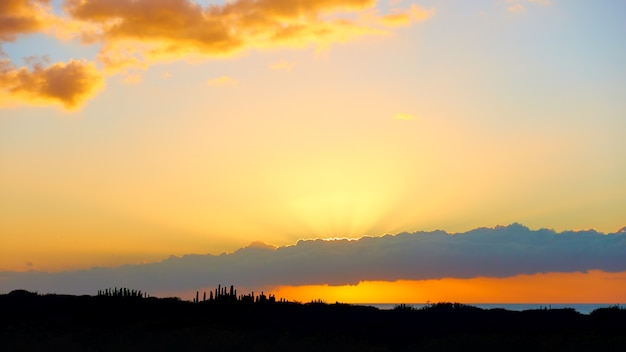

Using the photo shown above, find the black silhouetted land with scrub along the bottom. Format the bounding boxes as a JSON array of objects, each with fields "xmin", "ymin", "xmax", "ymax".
[{"xmin": 0, "ymin": 291, "xmax": 626, "ymax": 351}]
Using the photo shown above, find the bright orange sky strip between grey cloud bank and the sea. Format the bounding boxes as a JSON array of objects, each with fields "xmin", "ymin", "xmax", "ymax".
[{"xmin": 266, "ymin": 270, "xmax": 626, "ymax": 304}]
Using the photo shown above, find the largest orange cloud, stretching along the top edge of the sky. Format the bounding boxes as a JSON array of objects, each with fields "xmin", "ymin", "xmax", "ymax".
[{"xmin": 65, "ymin": 0, "xmax": 432, "ymax": 71}]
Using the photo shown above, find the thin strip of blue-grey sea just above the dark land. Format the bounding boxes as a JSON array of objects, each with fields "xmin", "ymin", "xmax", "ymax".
[{"xmin": 356, "ymin": 303, "xmax": 626, "ymax": 314}]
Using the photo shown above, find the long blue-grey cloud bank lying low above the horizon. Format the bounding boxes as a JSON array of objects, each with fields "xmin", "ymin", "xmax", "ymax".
[{"xmin": 0, "ymin": 224, "xmax": 626, "ymax": 294}]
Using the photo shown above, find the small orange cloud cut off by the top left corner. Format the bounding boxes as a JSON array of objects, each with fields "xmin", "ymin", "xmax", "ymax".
[{"xmin": 0, "ymin": 0, "xmax": 50, "ymax": 41}]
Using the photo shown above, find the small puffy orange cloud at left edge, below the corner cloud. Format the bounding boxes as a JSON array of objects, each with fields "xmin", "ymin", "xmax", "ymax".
[{"xmin": 0, "ymin": 60, "xmax": 104, "ymax": 110}]
